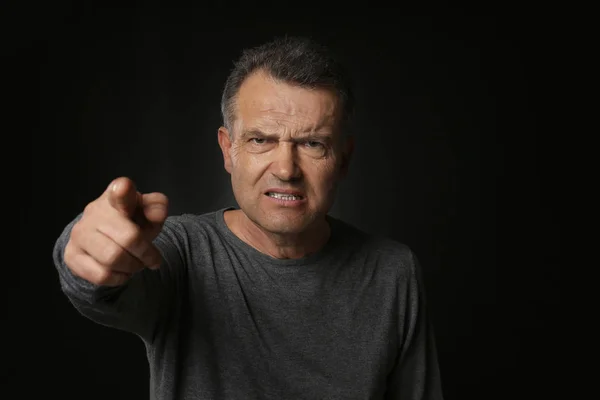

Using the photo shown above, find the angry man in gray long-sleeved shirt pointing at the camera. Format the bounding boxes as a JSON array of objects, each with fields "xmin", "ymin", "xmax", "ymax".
[{"xmin": 54, "ymin": 38, "xmax": 442, "ymax": 400}]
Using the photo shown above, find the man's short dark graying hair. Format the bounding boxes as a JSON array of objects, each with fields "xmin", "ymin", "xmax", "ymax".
[{"xmin": 221, "ymin": 37, "xmax": 354, "ymax": 135}]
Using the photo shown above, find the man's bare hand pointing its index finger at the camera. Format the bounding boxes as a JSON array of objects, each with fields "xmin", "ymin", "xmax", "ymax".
[{"xmin": 64, "ymin": 178, "xmax": 168, "ymax": 286}]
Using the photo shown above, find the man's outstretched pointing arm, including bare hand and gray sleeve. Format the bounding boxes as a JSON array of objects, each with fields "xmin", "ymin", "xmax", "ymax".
[{"xmin": 53, "ymin": 178, "xmax": 185, "ymax": 341}]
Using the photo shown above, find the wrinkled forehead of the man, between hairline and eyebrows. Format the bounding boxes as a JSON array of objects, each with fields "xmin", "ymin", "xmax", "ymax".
[{"xmin": 236, "ymin": 72, "xmax": 338, "ymax": 131}]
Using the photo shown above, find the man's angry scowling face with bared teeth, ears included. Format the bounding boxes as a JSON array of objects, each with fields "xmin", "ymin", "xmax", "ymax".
[{"xmin": 219, "ymin": 73, "xmax": 352, "ymax": 234}]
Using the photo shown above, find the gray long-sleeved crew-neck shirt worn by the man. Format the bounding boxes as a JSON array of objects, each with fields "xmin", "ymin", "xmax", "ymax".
[{"xmin": 53, "ymin": 207, "xmax": 442, "ymax": 400}]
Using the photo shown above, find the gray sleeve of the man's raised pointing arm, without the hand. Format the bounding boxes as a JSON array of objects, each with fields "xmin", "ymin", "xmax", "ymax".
[{"xmin": 53, "ymin": 214, "xmax": 186, "ymax": 342}]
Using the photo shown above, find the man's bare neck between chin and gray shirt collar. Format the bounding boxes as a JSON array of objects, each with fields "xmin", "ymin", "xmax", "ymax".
[{"xmin": 225, "ymin": 210, "xmax": 331, "ymax": 259}]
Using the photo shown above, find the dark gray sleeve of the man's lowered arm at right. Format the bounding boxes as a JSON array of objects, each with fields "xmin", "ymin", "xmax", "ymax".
[{"xmin": 385, "ymin": 252, "xmax": 443, "ymax": 400}]
